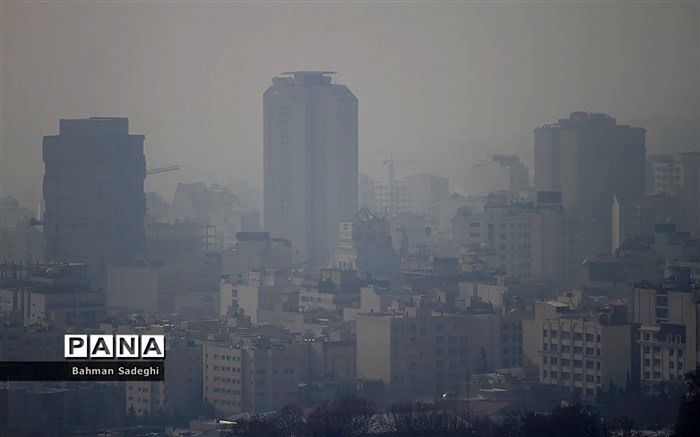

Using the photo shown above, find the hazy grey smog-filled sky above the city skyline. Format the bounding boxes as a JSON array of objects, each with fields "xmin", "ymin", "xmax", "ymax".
[{"xmin": 0, "ymin": 1, "xmax": 700, "ymax": 204}]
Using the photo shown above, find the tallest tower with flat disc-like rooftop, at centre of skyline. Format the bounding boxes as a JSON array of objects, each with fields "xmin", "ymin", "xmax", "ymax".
[{"xmin": 263, "ymin": 71, "xmax": 358, "ymax": 270}]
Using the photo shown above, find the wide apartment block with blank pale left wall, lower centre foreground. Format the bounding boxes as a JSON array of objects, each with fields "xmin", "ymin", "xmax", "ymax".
[{"xmin": 357, "ymin": 307, "xmax": 501, "ymax": 401}]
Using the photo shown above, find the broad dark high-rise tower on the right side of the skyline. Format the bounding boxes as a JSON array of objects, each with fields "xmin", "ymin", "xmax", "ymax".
[{"xmin": 535, "ymin": 112, "xmax": 645, "ymax": 256}]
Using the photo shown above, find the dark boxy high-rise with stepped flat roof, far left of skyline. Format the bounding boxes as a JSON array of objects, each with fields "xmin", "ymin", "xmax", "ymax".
[{"xmin": 43, "ymin": 117, "xmax": 146, "ymax": 286}]
